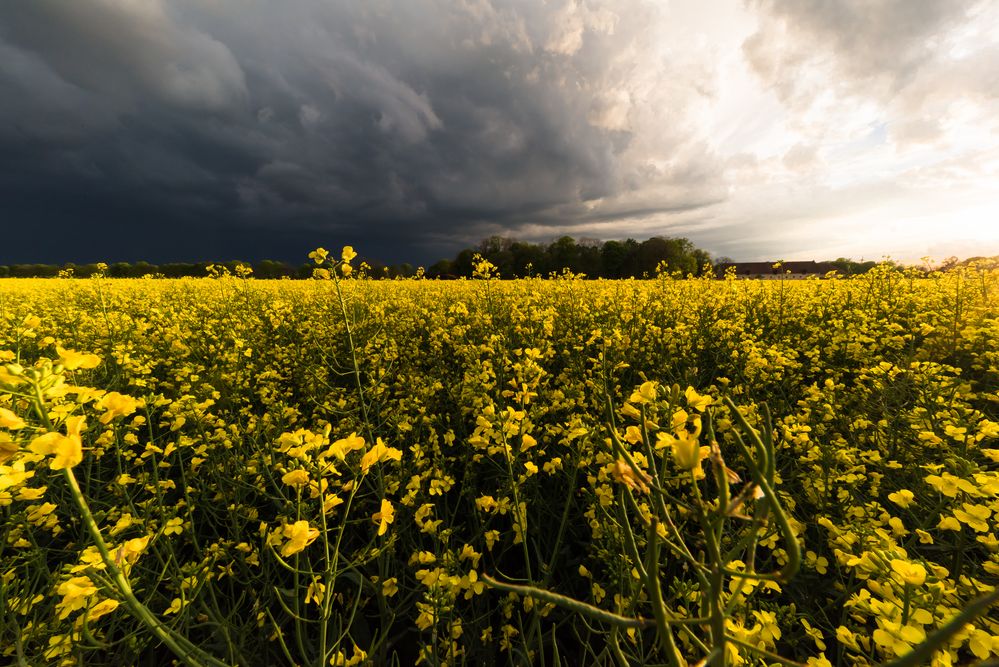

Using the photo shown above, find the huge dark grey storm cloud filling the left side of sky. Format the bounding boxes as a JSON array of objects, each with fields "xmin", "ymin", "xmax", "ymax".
[{"xmin": 0, "ymin": 0, "xmax": 719, "ymax": 262}]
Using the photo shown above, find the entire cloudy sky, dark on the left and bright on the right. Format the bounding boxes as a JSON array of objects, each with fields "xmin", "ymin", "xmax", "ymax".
[{"xmin": 0, "ymin": 0, "xmax": 999, "ymax": 264}]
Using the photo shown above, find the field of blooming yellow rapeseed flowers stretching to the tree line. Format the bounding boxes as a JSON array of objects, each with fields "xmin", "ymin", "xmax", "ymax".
[{"xmin": 0, "ymin": 249, "xmax": 999, "ymax": 667}]
